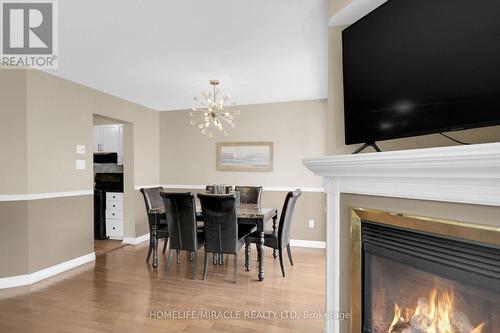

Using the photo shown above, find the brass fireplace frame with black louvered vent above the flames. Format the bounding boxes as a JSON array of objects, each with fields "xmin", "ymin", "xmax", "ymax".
[{"xmin": 350, "ymin": 208, "xmax": 500, "ymax": 333}]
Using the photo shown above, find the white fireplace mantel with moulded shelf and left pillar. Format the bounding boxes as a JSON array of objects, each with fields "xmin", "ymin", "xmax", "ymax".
[{"xmin": 304, "ymin": 143, "xmax": 500, "ymax": 333}]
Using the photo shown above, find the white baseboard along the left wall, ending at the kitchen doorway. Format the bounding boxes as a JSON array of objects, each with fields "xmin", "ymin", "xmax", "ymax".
[{"xmin": 0, "ymin": 252, "xmax": 95, "ymax": 289}]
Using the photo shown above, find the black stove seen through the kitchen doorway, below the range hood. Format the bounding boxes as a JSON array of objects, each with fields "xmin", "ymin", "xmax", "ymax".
[{"xmin": 94, "ymin": 173, "xmax": 123, "ymax": 239}]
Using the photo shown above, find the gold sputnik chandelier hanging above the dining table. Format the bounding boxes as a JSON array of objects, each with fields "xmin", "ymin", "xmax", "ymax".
[{"xmin": 191, "ymin": 80, "xmax": 240, "ymax": 138}]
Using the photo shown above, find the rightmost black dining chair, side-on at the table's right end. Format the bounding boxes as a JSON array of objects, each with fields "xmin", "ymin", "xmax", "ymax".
[{"xmin": 245, "ymin": 190, "xmax": 302, "ymax": 277}]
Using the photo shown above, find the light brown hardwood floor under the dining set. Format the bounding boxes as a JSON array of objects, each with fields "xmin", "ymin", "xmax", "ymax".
[{"xmin": 0, "ymin": 243, "xmax": 325, "ymax": 333}]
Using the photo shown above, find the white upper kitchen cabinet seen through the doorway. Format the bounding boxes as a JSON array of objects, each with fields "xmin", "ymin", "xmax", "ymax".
[{"xmin": 93, "ymin": 125, "xmax": 123, "ymax": 165}]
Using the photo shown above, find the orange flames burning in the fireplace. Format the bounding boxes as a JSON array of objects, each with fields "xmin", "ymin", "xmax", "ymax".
[{"xmin": 387, "ymin": 288, "xmax": 485, "ymax": 333}]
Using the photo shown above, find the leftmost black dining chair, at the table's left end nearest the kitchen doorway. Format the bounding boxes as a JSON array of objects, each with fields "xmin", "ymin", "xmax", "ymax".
[{"xmin": 141, "ymin": 187, "xmax": 168, "ymax": 261}]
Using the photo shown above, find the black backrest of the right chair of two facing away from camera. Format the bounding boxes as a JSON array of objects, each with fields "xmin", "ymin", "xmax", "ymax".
[{"xmin": 198, "ymin": 193, "xmax": 238, "ymax": 254}]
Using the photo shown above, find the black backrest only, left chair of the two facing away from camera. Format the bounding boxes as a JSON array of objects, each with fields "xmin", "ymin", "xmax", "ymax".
[{"xmin": 161, "ymin": 192, "xmax": 198, "ymax": 251}]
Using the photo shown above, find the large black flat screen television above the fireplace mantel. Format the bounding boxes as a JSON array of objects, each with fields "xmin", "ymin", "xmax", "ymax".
[{"xmin": 342, "ymin": 0, "xmax": 500, "ymax": 144}]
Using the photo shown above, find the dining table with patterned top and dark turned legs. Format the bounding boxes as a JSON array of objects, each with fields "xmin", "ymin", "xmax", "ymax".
[{"xmin": 149, "ymin": 203, "xmax": 278, "ymax": 281}]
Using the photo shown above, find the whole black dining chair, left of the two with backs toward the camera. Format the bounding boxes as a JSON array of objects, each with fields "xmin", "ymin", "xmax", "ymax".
[{"xmin": 160, "ymin": 192, "xmax": 204, "ymax": 279}]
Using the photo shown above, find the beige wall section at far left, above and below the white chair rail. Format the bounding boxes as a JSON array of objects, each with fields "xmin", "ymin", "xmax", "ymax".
[{"xmin": 0, "ymin": 69, "xmax": 28, "ymax": 278}]
